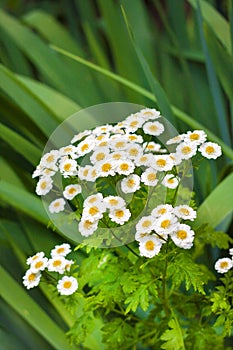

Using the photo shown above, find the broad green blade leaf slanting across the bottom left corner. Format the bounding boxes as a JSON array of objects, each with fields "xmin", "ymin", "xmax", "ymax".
[{"xmin": 0, "ymin": 266, "xmax": 75, "ymax": 350}]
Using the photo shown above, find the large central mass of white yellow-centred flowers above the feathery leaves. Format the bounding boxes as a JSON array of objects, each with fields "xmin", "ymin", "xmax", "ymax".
[{"xmin": 33, "ymin": 108, "xmax": 221, "ymax": 257}]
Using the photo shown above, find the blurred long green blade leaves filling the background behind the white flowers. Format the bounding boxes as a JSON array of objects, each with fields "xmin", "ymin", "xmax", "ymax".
[{"xmin": 0, "ymin": 0, "xmax": 233, "ymax": 350}]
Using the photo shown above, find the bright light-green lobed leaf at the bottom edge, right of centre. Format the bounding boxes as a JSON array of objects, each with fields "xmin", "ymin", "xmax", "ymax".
[{"xmin": 160, "ymin": 316, "xmax": 185, "ymax": 350}]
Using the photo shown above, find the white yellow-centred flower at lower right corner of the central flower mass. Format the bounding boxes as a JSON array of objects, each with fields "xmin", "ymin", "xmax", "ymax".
[{"xmin": 170, "ymin": 224, "xmax": 194, "ymax": 249}]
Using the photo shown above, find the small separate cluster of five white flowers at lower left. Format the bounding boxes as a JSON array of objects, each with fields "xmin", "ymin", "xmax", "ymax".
[{"xmin": 23, "ymin": 243, "xmax": 78, "ymax": 295}]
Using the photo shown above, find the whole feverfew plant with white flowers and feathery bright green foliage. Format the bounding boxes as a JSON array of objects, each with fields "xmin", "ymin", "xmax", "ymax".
[{"xmin": 23, "ymin": 108, "xmax": 233, "ymax": 350}]
